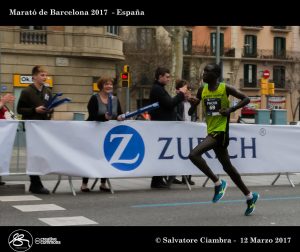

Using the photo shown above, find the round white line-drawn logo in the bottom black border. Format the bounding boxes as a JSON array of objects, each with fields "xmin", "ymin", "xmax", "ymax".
[{"xmin": 8, "ymin": 229, "xmax": 33, "ymax": 252}]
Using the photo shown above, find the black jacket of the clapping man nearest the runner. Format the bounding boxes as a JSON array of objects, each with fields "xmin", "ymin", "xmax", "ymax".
[{"xmin": 149, "ymin": 81, "xmax": 184, "ymax": 121}]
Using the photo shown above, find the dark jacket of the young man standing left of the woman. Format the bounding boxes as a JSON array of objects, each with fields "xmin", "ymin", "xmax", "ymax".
[{"xmin": 17, "ymin": 84, "xmax": 52, "ymax": 120}]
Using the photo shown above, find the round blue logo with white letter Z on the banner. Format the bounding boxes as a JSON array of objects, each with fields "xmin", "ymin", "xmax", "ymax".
[{"xmin": 103, "ymin": 125, "xmax": 145, "ymax": 171}]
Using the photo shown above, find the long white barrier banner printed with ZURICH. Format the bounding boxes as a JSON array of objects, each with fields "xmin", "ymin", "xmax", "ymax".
[{"xmin": 26, "ymin": 121, "xmax": 300, "ymax": 178}]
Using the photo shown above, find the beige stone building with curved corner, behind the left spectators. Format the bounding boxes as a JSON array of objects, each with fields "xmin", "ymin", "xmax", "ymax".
[{"xmin": 0, "ymin": 26, "xmax": 124, "ymax": 120}]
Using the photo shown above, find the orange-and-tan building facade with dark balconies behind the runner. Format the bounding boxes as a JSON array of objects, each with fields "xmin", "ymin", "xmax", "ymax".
[{"xmin": 184, "ymin": 26, "xmax": 300, "ymax": 121}]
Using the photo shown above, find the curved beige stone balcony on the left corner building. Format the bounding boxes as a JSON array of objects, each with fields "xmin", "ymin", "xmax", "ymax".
[{"xmin": 1, "ymin": 26, "xmax": 124, "ymax": 60}]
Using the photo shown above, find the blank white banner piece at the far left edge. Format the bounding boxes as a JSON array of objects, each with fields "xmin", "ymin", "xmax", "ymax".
[{"xmin": 0, "ymin": 120, "xmax": 18, "ymax": 175}]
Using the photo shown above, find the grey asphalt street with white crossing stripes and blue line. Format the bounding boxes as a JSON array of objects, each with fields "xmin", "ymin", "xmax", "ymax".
[{"xmin": 0, "ymin": 174, "xmax": 300, "ymax": 226}]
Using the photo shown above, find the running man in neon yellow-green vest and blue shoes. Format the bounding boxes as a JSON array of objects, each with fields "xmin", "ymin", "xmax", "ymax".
[{"xmin": 189, "ymin": 64, "xmax": 259, "ymax": 216}]
